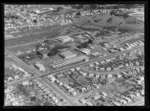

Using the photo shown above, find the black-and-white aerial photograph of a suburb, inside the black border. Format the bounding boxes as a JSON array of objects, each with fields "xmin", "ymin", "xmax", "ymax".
[{"xmin": 3, "ymin": 3, "xmax": 145, "ymax": 107}]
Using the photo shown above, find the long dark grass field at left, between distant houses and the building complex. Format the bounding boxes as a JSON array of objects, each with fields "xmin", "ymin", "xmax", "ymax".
[{"xmin": 5, "ymin": 26, "xmax": 71, "ymax": 47}]
